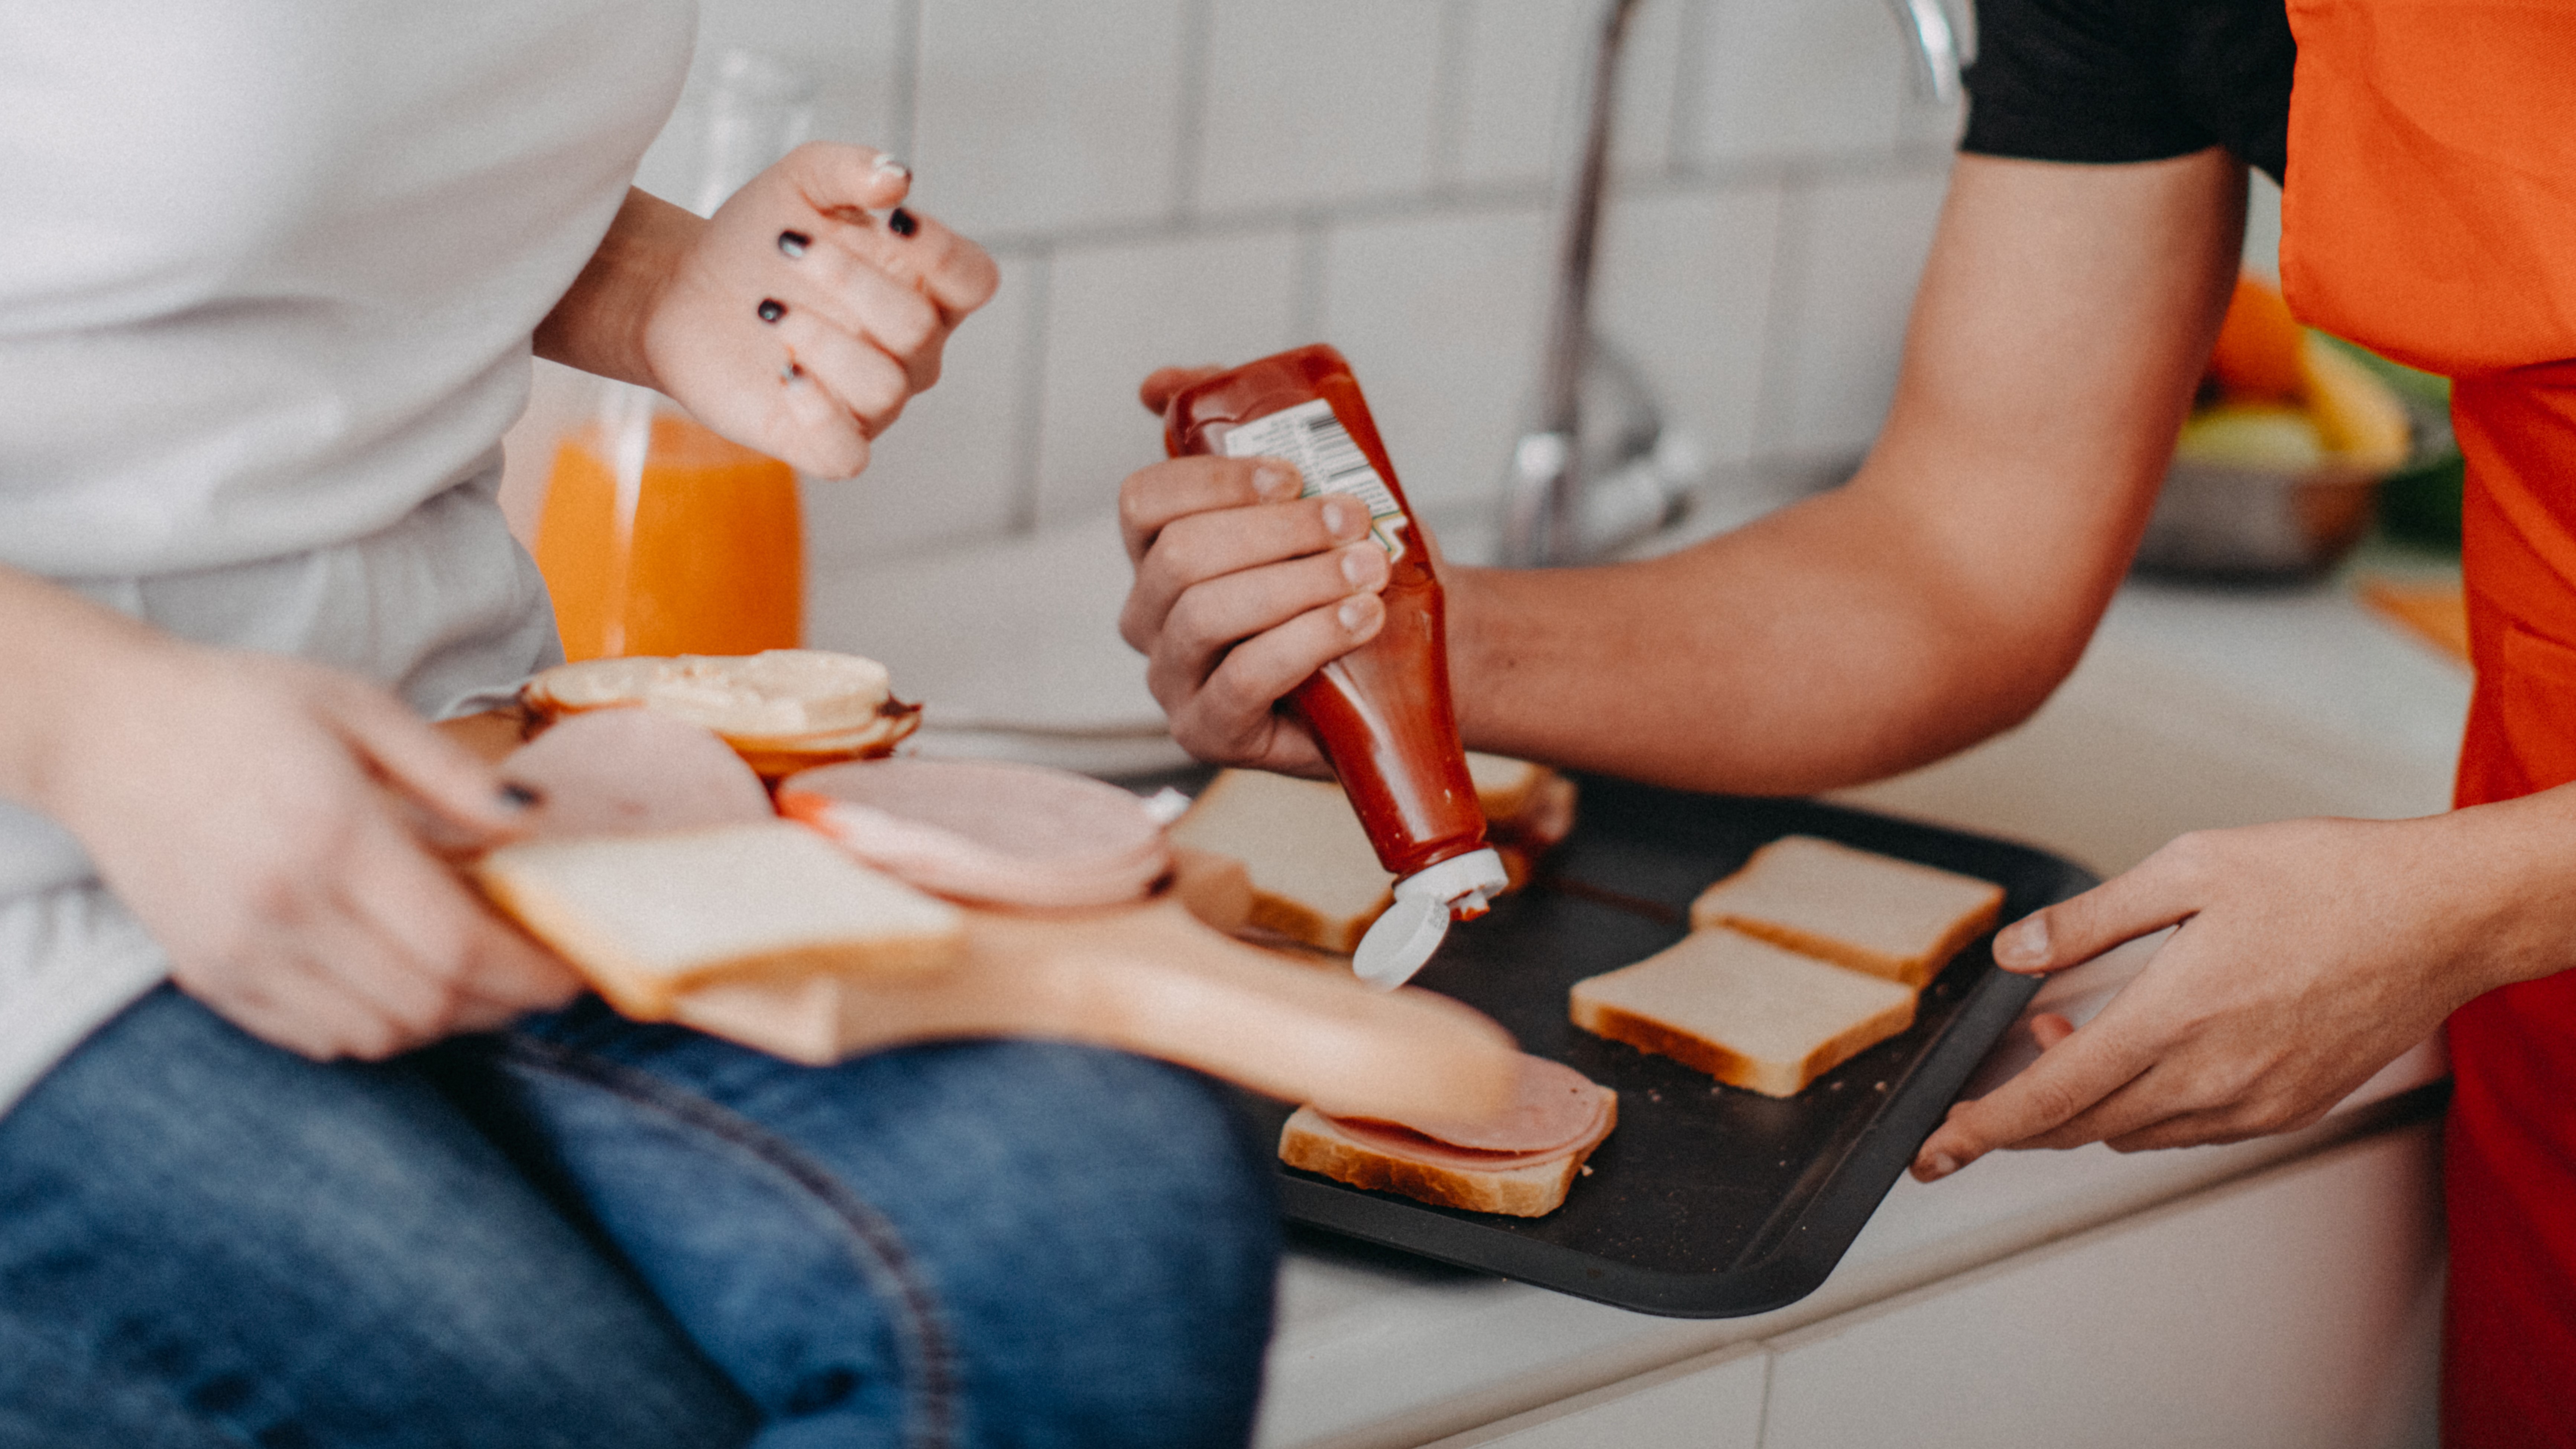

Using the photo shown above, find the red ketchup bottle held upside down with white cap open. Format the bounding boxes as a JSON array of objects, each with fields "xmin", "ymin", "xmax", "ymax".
[{"xmin": 1162, "ymin": 345, "xmax": 1504, "ymax": 986}]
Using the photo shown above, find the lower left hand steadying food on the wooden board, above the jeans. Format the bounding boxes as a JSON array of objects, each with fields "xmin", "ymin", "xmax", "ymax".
[{"xmin": 0, "ymin": 592, "xmax": 580, "ymax": 1058}]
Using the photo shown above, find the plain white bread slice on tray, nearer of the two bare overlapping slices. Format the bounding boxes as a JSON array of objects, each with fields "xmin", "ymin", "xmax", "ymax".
[{"xmin": 1571, "ymin": 929, "xmax": 1914, "ymax": 1096}]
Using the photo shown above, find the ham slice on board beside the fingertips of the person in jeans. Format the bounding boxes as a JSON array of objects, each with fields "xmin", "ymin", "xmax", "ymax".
[{"xmin": 500, "ymin": 708, "xmax": 773, "ymax": 839}]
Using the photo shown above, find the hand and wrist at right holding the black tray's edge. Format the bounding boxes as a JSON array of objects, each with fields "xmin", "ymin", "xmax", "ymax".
[{"xmin": 1914, "ymin": 813, "xmax": 2576, "ymax": 1181}]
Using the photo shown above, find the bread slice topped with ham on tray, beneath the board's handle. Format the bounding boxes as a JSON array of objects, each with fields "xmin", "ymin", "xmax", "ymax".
[{"xmin": 1280, "ymin": 1055, "xmax": 1618, "ymax": 1218}]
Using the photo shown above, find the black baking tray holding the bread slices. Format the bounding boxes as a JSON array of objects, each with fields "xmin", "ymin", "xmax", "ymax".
[{"xmin": 1226, "ymin": 777, "xmax": 2094, "ymax": 1318}]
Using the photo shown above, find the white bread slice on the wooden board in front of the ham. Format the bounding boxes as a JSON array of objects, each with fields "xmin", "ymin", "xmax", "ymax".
[{"xmin": 474, "ymin": 821, "xmax": 966, "ymax": 1022}]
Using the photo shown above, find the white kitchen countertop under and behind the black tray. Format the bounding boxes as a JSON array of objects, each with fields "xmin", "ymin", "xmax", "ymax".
[{"xmin": 811, "ymin": 504, "xmax": 2468, "ymax": 1449}]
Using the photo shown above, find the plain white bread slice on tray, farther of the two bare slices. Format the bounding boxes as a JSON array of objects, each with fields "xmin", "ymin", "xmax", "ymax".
[{"xmin": 1690, "ymin": 836, "xmax": 2004, "ymax": 988}]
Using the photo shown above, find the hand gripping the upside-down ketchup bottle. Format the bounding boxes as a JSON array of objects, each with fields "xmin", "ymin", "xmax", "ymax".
[{"xmin": 1118, "ymin": 368, "xmax": 1440, "ymax": 775}]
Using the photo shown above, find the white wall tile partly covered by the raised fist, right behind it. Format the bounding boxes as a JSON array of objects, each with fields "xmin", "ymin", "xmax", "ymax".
[{"xmin": 804, "ymin": 255, "xmax": 1041, "ymax": 571}]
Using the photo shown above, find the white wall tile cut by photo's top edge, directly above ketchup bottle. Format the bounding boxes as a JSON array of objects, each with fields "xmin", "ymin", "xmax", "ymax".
[{"xmin": 1195, "ymin": 0, "xmax": 1442, "ymax": 214}]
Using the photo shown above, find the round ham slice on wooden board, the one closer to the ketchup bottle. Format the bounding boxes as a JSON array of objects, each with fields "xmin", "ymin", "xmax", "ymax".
[{"xmin": 778, "ymin": 759, "xmax": 1172, "ymax": 908}]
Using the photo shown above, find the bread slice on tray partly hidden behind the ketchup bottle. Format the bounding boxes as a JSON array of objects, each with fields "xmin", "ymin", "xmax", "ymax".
[{"xmin": 1172, "ymin": 767, "xmax": 1574, "ymax": 955}]
